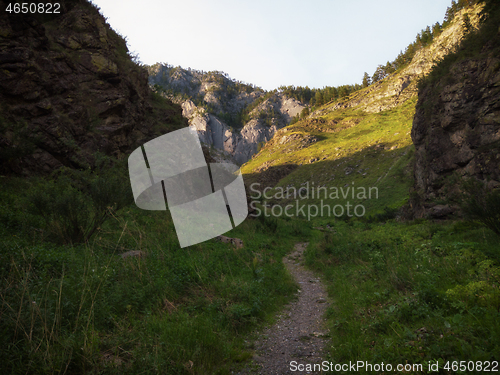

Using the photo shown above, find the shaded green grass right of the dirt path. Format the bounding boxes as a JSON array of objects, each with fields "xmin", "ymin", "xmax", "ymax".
[{"xmin": 306, "ymin": 221, "xmax": 500, "ymax": 373}]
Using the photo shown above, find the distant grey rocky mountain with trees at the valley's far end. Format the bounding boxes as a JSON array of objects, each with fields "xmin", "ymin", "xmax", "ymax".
[{"xmin": 148, "ymin": 64, "xmax": 306, "ymax": 164}]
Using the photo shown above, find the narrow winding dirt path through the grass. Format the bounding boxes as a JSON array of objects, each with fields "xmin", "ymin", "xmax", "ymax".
[{"xmin": 239, "ymin": 243, "xmax": 328, "ymax": 375}]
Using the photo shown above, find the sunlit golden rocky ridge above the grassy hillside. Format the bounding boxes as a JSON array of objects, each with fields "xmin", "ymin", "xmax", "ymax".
[{"xmin": 320, "ymin": 4, "xmax": 482, "ymax": 116}]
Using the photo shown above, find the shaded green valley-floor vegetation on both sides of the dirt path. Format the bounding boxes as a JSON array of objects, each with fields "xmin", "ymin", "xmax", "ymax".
[{"xmin": 0, "ymin": 167, "xmax": 500, "ymax": 374}]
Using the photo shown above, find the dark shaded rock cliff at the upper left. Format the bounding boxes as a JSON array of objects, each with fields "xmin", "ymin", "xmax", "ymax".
[{"xmin": 0, "ymin": 0, "xmax": 187, "ymax": 174}]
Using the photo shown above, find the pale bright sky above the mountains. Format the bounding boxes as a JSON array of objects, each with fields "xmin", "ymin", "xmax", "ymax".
[{"xmin": 91, "ymin": 0, "xmax": 451, "ymax": 90}]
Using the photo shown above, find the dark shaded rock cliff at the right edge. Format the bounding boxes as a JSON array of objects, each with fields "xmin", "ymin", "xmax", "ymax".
[{"xmin": 411, "ymin": 9, "xmax": 500, "ymax": 216}]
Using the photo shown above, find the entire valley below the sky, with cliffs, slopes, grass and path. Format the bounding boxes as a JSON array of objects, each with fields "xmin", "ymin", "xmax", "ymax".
[{"xmin": 0, "ymin": 0, "xmax": 500, "ymax": 375}]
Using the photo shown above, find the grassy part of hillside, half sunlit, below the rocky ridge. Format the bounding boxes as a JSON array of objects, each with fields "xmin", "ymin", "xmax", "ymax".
[{"xmin": 242, "ymin": 98, "xmax": 416, "ymax": 221}]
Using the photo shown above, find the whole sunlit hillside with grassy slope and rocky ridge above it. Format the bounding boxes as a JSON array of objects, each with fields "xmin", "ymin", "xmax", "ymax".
[{"xmin": 242, "ymin": 0, "xmax": 490, "ymax": 220}]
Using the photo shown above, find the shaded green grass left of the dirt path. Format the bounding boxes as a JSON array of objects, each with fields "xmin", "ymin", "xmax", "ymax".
[{"xmin": 0, "ymin": 177, "xmax": 308, "ymax": 374}]
